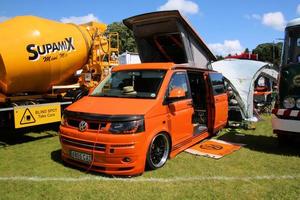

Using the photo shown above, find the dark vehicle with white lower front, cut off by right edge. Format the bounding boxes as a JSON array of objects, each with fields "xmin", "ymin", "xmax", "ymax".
[{"xmin": 272, "ymin": 18, "xmax": 300, "ymax": 142}]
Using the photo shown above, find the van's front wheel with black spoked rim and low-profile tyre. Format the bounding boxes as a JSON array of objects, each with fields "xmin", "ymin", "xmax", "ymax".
[{"xmin": 146, "ymin": 133, "xmax": 170, "ymax": 170}]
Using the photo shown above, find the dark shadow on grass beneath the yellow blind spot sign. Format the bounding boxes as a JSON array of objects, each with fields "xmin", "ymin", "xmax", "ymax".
[{"xmin": 0, "ymin": 123, "xmax": 59, "ymax": 148}]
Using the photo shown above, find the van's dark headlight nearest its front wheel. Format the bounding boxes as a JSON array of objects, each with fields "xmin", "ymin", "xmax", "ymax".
[{"xmin": 109, "ymin": 120, "xmax": 145, "ymax": 134}]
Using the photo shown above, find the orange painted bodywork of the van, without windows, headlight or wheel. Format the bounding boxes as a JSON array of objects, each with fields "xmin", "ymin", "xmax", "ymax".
[{"xmin": 60, "ymin": 63, "xmax": 227, "ymax": 175}]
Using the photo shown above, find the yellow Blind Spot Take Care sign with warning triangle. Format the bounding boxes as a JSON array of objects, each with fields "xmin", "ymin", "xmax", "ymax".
[{"xmin": 14, "ymin": 103, "xmax": 61, "ymax": 128}]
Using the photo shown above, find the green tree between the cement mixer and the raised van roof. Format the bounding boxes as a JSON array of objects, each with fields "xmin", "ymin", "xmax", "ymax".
[{"xmin": 106, "ymin": 22, "xmax": 137, "ymax": 53}]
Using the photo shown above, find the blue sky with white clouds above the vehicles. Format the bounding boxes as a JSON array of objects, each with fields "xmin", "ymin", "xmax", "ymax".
[{"xmin": 0, "ymin": 0, "xmax": 300, "ymax": 55}]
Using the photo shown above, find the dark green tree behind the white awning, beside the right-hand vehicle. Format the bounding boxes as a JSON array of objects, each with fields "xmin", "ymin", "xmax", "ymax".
[{"xmin": 252, "ymin": 42, "xmax": 282, "ymax": 66}]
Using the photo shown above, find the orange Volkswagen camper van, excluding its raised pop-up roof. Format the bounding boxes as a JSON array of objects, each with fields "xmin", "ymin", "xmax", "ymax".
[{"xmin": 60, "ymin": 63, "xmax": 228, "ymax": 175}]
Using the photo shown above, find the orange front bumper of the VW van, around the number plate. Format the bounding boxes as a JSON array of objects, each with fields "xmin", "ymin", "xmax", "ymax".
[{"xmin": 60, "ymin": 126, "xmax": 147, "ymax": 175}]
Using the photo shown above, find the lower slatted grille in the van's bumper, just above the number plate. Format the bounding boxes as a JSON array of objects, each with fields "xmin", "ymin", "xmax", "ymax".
[{"xmin": 61, "ymin": 137, "xmax": 105, "ymax": 151}]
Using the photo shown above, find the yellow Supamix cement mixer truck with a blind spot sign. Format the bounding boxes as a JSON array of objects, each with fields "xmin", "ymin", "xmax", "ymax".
[{"xmin": 0, "ymin": 16, "xmax": 119, "ymax": 128}]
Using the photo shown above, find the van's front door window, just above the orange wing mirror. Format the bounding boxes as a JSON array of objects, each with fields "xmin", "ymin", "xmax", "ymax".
[{"xmin": 168, "ymin": 72, "xmax": 190, "ymax": 97}]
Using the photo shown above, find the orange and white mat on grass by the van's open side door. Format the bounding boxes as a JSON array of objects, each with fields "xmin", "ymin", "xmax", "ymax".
[{"xmin": 185, "ymin": 139, "xmax": 244, "ymax": 159}]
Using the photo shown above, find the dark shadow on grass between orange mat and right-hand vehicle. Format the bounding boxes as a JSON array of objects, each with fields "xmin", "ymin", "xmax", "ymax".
[{"xmin": 218, "ymin": 129, "xmax": 300, "ymax": 156}]
